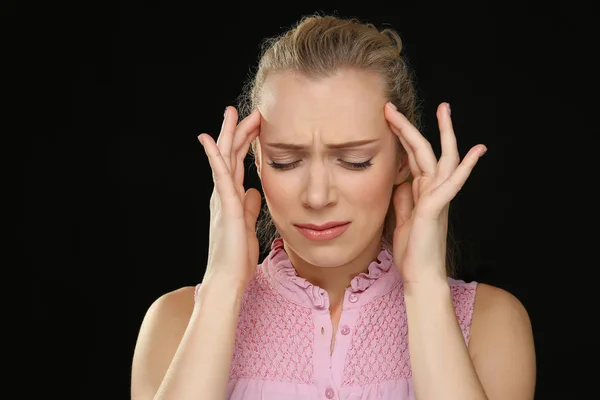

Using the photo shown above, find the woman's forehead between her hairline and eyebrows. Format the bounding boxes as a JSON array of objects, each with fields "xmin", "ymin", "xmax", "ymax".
[{"xmin": 259, "ymin": 70, "xmax": 387, "ymax": 141}]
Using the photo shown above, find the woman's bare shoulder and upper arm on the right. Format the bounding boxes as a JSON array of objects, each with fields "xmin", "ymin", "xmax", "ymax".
[{"xmin": 469, "ymin": 283, "xmax": 536, "ymax": 399}]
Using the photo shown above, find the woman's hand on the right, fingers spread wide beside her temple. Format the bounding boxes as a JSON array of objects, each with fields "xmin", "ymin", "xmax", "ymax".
[{"xmin": 385, "ymin": 103, "xmax": 487, "ymax": 284}]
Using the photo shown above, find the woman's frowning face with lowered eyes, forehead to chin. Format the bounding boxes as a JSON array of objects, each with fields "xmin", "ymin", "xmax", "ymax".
[{"xmin": 256, "ymin": 70, "xmax": 401, "ymax": 267}]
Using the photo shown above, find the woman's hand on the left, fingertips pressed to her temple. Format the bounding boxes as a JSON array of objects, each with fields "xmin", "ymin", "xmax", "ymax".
[{"xmin": 198, "ymin": 107, "xmax": 261, "ymax": 288}]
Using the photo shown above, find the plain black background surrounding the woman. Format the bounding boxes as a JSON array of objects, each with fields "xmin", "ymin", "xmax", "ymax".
[{"xmin": 21, "ymin": 0, "xmax": 596, "ymax": 399}]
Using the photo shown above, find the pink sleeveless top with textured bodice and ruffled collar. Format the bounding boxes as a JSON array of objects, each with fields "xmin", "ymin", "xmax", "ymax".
[{"xmin": 196, "ymin": 238, "xmax": 477, "ymax": 400}]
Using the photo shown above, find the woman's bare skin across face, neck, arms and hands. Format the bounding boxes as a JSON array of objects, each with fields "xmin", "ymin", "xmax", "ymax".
[{"xmin": 132, "ymin": 70, "xmax": 536, "ymax": 400}]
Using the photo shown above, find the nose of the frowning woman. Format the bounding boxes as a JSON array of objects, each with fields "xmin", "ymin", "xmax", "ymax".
[{"xmin": 301, "ymin": 162, "xmax": 337, "ymax": 210}]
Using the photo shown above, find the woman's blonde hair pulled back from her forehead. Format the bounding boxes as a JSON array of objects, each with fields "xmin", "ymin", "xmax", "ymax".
[{"xmin": 238, "ymin": 15, "xmax": 453, "ymax": 275}]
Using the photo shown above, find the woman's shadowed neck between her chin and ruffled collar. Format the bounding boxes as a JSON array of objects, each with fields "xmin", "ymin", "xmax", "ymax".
[{"xmin": 283, "ymin": 237, "xmax": 381, "ymax": 310}]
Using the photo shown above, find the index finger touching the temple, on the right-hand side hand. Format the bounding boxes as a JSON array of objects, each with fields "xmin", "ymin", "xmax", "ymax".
[{"xmin": 385, "ymin": 103, "xmax": 437, "ymax": 176}]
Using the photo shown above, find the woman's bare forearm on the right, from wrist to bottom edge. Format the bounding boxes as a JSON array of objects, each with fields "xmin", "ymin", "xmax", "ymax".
[{"xmin": 404, "ymin": 279, "xmax": 486, "ymax": 400}]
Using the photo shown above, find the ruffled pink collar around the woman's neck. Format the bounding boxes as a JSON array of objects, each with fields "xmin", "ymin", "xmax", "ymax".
[{"xmin": 262, "ymin": 238, "xmax": 400, "ymax": 309}]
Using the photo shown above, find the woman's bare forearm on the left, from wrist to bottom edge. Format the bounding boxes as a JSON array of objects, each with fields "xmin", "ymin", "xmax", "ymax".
[{"xmin": 155, "ymin": 280, "xmax": 243, "ymax": 400}]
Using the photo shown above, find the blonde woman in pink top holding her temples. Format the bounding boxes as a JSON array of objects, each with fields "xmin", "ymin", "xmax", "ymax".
[{"xmin": 132, "ymin": 17, "xmax": 535, "ymax": 400}]
